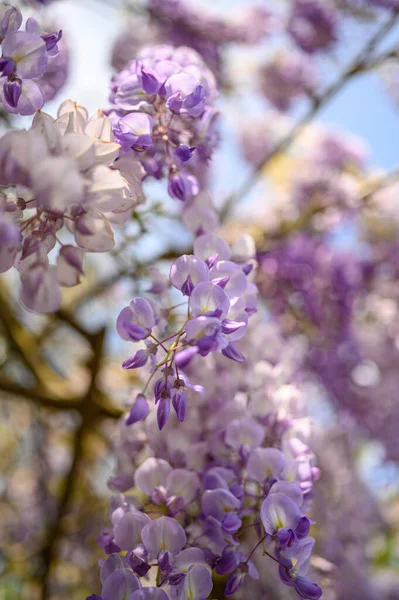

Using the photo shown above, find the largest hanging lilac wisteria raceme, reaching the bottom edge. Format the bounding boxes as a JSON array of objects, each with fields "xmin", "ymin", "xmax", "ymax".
[{"xmin": 86, "ymin": 322, "xmax": 321, "ymax": 600}]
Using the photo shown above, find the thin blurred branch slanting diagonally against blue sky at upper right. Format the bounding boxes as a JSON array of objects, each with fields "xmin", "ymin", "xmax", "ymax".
[{"xmin": 220, "ymin": 8, "xmax": 399, "ymax": 221}]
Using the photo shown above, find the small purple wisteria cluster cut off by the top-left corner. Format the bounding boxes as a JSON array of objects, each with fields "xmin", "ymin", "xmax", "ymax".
[{"xmin": 0, "ymin": 5, "xmax": 62, "ymax": 115}]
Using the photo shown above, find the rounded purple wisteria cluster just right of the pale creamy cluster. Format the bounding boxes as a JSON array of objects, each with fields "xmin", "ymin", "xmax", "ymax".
[{"xmin": 108, "ymin": 45, "xmax": 218, "ymax": 202}]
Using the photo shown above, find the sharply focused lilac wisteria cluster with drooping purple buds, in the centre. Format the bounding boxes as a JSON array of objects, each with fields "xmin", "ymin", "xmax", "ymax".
[{"xmin": 117, "ymin": 234, "xmax": 257, "ymax": 429}]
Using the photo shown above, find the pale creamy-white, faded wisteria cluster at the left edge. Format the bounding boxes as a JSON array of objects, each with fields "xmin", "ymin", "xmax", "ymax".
[{"xmin": 0, "ymin": 100, "xmax": 142, "ymax": 313}]
